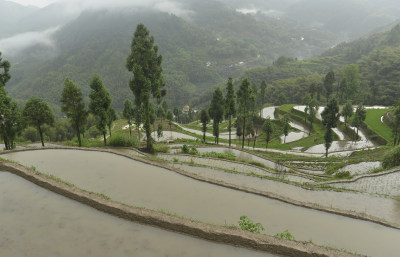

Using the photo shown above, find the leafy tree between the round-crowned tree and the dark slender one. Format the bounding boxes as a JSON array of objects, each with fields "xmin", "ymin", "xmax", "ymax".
[{"xmin": 61, "ymin": 78, "xmax": 88, "ymax": 146}]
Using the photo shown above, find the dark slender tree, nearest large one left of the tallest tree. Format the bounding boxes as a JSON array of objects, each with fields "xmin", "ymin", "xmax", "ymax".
[{"xmin": 89, "ymin": 75, "xmax": 111, "ymax": 145}]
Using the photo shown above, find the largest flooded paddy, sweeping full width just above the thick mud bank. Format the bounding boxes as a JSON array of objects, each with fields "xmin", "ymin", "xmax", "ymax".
[{"xmin": 3, "ymin": 150, "xmax": 400, "ymax": 256}]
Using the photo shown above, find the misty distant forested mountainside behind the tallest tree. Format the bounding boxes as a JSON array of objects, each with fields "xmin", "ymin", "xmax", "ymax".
[{"xmin": 3, "ymin": 0, "xmax": 333, "ymax": 109}]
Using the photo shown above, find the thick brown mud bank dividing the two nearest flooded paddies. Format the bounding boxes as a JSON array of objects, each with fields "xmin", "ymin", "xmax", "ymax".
[{"xmin": 0, "ymin": 162, "xmax": 356, "ymax": 257}]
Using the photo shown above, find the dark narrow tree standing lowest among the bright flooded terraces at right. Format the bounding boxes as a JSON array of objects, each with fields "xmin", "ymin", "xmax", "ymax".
[{"xmin": 321, "ymin": 98, "xmax": 340, "ymax": 157}]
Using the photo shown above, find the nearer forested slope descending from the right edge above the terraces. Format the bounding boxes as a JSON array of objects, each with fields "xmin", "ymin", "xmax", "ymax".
[{"xmin": 238, "ymin": 22, "xmax": 400, "ymax": 105}]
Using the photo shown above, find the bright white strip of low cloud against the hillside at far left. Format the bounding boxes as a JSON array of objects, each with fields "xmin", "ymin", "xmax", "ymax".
[{"xmin": 0, "ymin": 27, "xmax": 58, "ymax": 56}]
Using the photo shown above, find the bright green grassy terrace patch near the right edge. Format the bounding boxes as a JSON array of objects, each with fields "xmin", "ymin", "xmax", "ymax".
[{"xmin": 364, "ymin": 109, "xmax": 393, "ymax": 142}]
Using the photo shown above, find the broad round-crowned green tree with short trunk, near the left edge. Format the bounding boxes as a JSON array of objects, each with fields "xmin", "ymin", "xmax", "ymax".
[{"xmin": 22, "ymin": 97, "xmax": 54, "ymax": 146}]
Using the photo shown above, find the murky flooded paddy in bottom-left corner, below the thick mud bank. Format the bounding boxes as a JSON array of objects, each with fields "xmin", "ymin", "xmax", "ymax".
[{"xmin": 0, "ymin": 172, "xmax": 274, "ymax": 257}]
